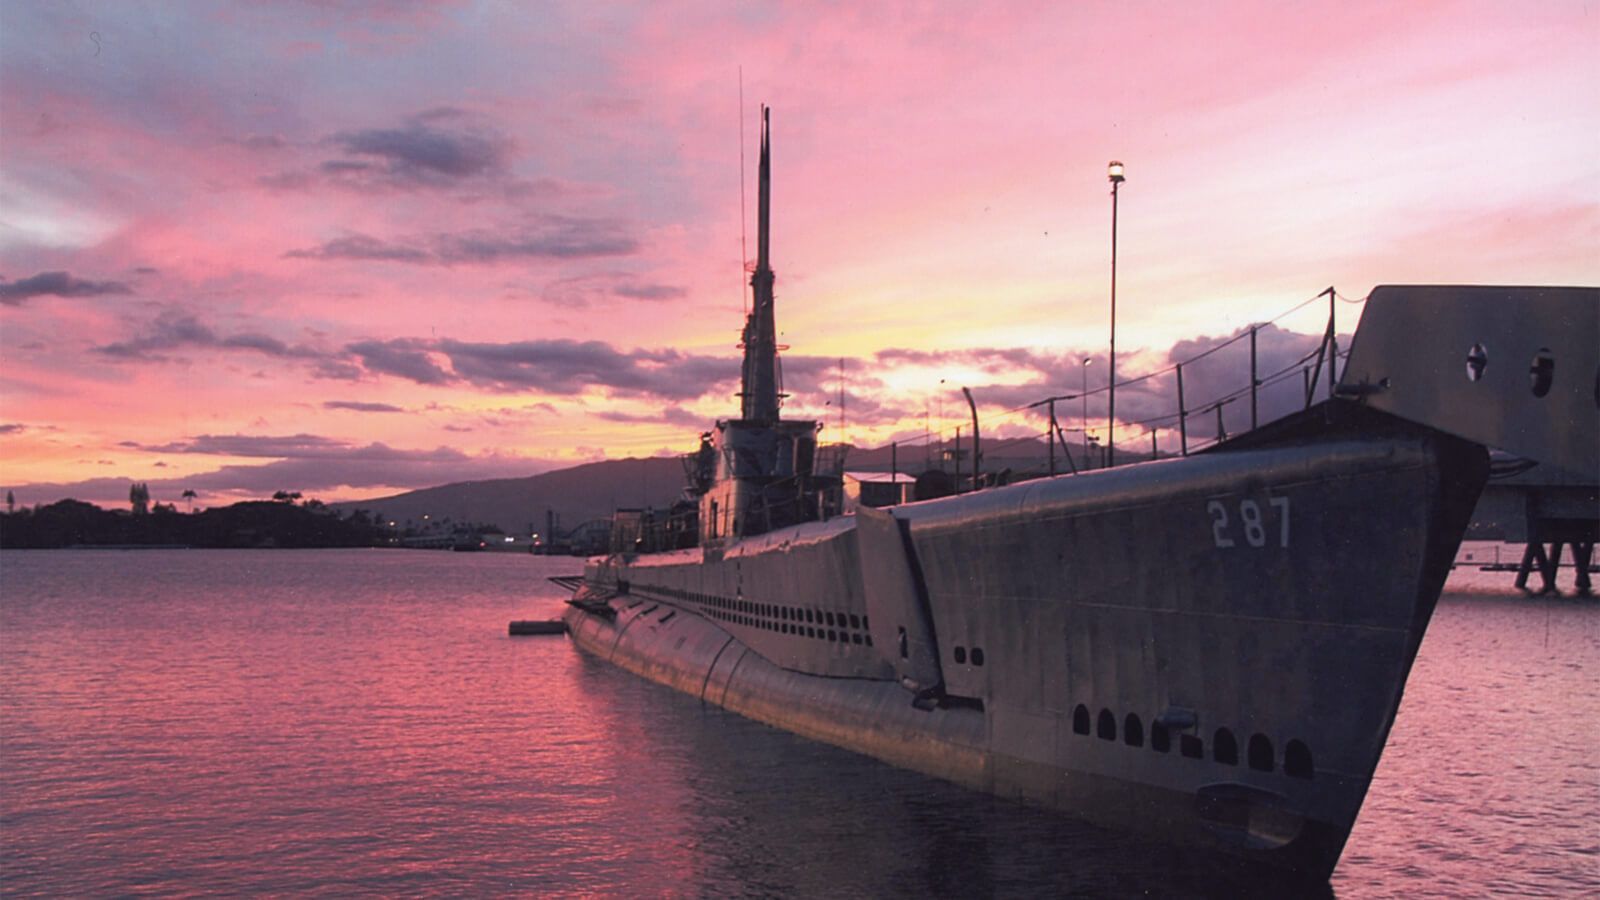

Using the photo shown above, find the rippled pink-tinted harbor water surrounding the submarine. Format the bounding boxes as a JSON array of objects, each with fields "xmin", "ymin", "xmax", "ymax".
[{"xmin": 0, "ymin": 551, "xmax": 1600, "ymax": 897}]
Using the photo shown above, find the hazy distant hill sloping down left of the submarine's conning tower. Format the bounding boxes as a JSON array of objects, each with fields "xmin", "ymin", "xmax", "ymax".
[{"xmin": 331, "ymin": 456, "xmax": 683, "ymax": 533}]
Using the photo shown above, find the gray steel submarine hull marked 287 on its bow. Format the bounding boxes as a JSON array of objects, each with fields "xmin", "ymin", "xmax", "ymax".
[{"xmin": 566, "ymin": 423, "xmax": 1483, "ymax": 881}]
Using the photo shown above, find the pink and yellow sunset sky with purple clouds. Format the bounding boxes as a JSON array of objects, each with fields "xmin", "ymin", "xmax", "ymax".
[{"xmin": 0, "ymin": 0, "xmax": 1600, "ymax": 504}]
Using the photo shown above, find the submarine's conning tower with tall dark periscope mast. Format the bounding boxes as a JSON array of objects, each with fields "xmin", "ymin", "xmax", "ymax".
[{"xmin": 699, "ymin": 107, "xmax": 819, "ymax": 538}]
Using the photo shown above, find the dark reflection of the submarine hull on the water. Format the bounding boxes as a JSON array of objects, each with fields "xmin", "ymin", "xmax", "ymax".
[{"xmin": 563, "ymin": 646, "xmax": 1331, "ymax": 897}]
